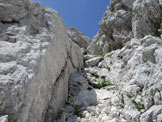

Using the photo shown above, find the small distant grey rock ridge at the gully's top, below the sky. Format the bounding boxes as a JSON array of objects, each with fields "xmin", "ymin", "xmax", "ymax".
[{"xmin": 68, "ymin": 27, "xmax": 91, "ymax": 49}]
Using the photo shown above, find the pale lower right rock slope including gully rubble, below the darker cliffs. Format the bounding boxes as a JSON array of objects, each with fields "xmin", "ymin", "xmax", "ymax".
[{"xmin": 61, "ymin": 35, "xmax": 162, "ymax": 122}]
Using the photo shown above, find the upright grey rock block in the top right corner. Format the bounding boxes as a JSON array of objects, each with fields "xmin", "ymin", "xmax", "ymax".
[{"xmin": 132, "ymin": 0, "xmax": 162, "ymax": 38}]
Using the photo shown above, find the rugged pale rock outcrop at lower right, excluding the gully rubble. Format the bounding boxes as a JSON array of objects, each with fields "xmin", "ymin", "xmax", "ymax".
[{"xmin": 98, "ymin": 36, "xmax": 162, "ymax": 122}]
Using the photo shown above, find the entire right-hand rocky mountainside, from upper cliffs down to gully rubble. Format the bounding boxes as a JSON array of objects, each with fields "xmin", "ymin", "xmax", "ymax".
[{"xmin": 58, "ymin": 0, "xmax": 162, "ymax": 122}]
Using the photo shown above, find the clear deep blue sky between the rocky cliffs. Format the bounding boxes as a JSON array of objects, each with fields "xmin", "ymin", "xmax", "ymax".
[{"xmin": 32, "ymin": 0, "xmax": 109, "ymax": 38}]
